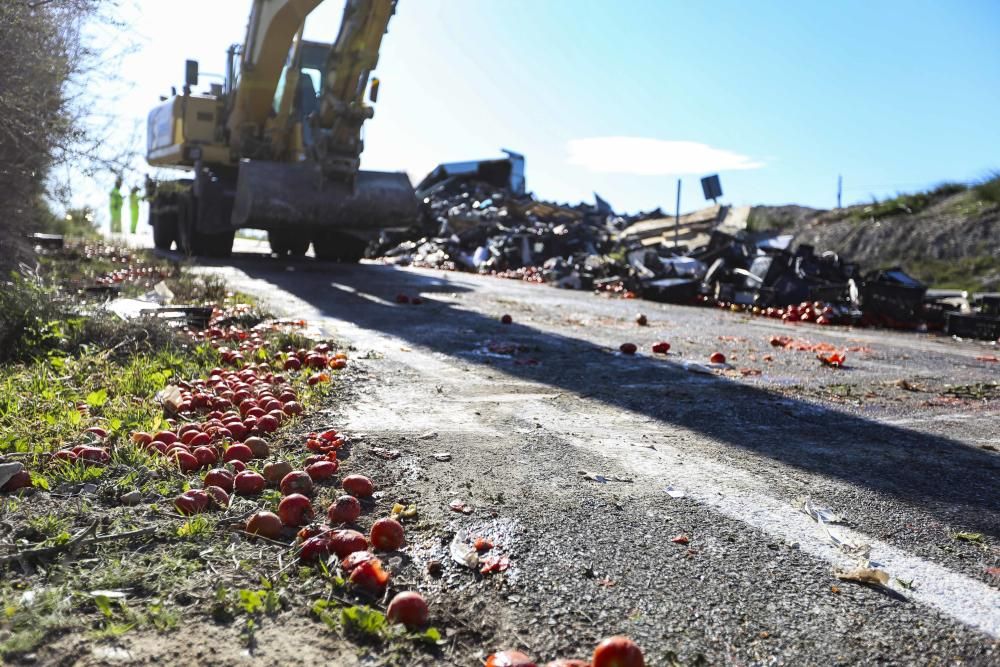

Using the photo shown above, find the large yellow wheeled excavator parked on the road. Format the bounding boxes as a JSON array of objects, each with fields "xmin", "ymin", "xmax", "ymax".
[{"xmin": 146, "ymin": 0, "xmax": 418, "ymax": 261}]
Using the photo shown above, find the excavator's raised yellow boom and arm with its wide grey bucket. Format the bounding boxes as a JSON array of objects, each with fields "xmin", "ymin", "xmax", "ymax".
[{"xmin": 227, "ymin": 0, "xmax": 417, "ymax": 235}]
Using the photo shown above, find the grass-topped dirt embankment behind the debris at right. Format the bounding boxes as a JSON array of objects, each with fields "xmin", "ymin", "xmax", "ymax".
[{"xmin": 750, "ymin": 188, "xmax": 1000, "ymax": 291}]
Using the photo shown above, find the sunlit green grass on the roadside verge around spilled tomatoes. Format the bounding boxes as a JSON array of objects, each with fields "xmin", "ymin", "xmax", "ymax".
[{"xmin": 0, "ymin": 245, "xmax": 356, "ymax": 663}]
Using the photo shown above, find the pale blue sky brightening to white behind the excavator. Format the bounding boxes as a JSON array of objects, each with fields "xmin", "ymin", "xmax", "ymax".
[{"xmin": 78, "ymin": 0, "xmax": 1000, "ymax": 224}]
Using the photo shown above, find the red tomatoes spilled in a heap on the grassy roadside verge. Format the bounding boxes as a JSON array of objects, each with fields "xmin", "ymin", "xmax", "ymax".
[{"xmin": 142, "ymin": 344, "xmax": 428, "ymax": 628}]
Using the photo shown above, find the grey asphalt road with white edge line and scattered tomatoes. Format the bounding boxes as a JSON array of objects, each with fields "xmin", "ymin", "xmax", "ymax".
[{"xmin": 182, "ymin": 247, "xmax": 1000, "ymax": 665}]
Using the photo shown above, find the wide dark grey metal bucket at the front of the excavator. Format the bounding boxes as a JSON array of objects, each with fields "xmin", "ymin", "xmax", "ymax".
[{"xmin": 232, "ymin": 160, "xmax": 418, "ymax": 235}]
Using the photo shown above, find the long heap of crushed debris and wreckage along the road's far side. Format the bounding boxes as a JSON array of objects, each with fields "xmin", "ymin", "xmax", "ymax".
[{"xmin": 368, "ymin": 152, "xmax": 1000, "ymax": 340}]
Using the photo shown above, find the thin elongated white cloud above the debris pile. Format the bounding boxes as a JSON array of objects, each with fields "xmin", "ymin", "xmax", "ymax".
[{"xmin": 566, "ymin": 137, "xmax": 764, "ymax": 176}]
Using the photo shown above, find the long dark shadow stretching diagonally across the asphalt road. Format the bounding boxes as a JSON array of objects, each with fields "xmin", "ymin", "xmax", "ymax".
[{"xmin": 225, "ymin": 258, "xmax": 1000, "ymax": 535}]
